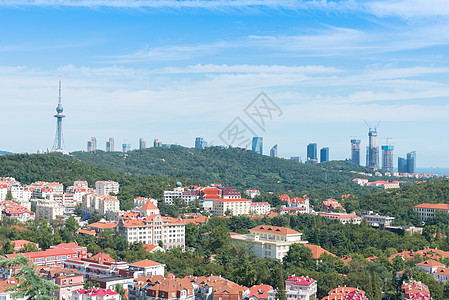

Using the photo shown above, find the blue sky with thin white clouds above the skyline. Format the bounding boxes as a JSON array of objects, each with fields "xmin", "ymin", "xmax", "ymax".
[{"xmin": 0, "ymin": 0, "xmax": 449, "ymax": 167}]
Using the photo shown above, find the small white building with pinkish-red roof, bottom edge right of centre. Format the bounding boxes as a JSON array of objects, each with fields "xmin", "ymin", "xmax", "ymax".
[{"xmin": 268, "ymin": 276, "xmax": 318, "ymax": 300}]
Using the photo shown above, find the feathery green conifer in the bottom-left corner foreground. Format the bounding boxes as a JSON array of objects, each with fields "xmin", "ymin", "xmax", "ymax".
[{"xmin": 0, "ymin": 254, "xmax": 59, "ymax": 300}]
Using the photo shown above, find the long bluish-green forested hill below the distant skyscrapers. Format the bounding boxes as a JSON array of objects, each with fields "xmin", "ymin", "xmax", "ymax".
[{"xmin": 72, "ymin": 146, "xmax": 378, "ymax": 198}]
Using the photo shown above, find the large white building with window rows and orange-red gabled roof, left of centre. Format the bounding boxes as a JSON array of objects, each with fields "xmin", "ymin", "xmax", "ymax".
[{"xmin": 117, "ymin": 214, "xmax": 185, "ymax": 249}]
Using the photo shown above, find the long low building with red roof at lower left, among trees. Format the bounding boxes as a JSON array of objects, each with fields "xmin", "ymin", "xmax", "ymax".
[{"xmin": 6, "ymin": 242, "xmax": 87, "ymax": 266}]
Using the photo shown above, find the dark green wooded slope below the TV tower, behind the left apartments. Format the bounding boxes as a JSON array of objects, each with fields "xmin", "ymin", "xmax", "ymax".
[{"xmin": 0, "ymin": 154, "xmax": 197, "ymax": 209}]
